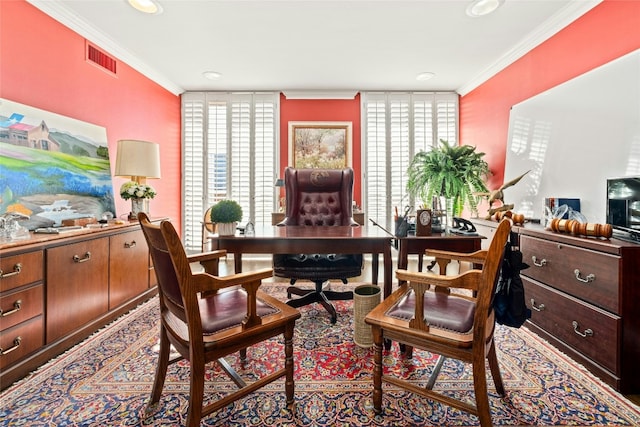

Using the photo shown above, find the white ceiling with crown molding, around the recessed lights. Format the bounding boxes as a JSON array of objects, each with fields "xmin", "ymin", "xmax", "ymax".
[{"xmin": 28, "ymin": 0, "xmax": 601, "ymax": 95}]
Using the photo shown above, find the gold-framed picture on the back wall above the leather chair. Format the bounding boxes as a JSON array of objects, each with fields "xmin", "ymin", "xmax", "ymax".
[{"xmin": 289, "ymin": 122, "xmax": 352, "ymax": 169}]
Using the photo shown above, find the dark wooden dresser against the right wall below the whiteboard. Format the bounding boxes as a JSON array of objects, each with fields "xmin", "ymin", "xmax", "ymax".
[{"xmin": 474, "ymin": 220, "xmax": 640, "ymax": 394}]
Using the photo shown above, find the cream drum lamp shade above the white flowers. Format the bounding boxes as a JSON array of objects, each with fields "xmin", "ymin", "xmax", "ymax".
[{"xmin": 115, "ymin": 139, "xmax": 160, "ymax": 180}]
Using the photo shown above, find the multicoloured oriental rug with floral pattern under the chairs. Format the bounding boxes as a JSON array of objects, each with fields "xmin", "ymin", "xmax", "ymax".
[{"xmin": 0, "ymin": 283, "xmax": 640, "ymax": 427}]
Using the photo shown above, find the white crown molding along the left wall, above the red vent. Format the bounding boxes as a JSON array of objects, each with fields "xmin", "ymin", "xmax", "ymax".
[{"xmin": 27, "ymin": 0, "xmax": 184, "ymax": 95}]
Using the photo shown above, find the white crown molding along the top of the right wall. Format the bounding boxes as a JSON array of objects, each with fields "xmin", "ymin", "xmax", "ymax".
[{"xmin": 456, "ymin": 0, "xmax": 603, "ymax": 96}]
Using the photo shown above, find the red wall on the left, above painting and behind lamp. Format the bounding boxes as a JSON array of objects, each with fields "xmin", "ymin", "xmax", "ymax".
[{"xmin": 0, "ymin": 0, "xmax": 182, "ymax": 230}]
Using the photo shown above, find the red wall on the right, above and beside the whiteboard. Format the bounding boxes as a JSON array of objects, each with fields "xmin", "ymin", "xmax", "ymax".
[{"xmin": 460, "ymin": 0, "xmax": 640, "ymax": 193}]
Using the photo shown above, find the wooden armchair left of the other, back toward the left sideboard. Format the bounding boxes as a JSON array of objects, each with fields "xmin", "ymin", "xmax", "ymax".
[{"xmin": 138, "ymin": 213, "xmax": 300, "ymax": 427}]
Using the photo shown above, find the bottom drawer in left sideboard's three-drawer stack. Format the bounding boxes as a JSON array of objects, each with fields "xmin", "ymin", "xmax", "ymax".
[{"xmin": 0, "ymin": 315, "xmax": 44, "ymax": 371}]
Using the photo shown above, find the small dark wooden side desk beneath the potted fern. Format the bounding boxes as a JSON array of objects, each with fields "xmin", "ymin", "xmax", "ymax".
[{"xmin": 398, "ymin": 233, "xmax": 485, "ymax": 270}]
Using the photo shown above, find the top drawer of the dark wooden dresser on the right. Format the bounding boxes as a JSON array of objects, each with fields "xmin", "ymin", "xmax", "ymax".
[{"xmin": 520, "ymin": 236, "xmax": 621, "ymax": 314}]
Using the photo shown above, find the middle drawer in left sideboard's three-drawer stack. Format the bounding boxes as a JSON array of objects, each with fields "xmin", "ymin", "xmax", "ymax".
[{"xmin": 0, "ymin": 285, "xmax": 44, "ymax": 331}]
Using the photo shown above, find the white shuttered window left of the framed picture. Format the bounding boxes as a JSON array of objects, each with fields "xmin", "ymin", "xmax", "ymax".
[{"xmin": 182, "ymin": 92, "xmax": 279, "ymax": 250}]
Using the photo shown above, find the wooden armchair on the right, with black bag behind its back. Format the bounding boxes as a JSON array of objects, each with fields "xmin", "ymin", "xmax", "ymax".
[{"xmin": 365, "ymin": 219, "xmax": 511, "ymax": 427}]
